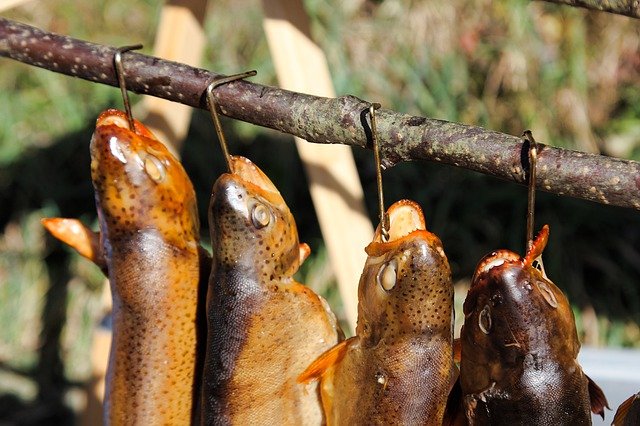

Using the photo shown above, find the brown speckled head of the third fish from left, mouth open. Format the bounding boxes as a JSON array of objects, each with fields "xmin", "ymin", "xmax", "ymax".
[{"xmin": 356, "ymin": 200, "xmax": 453, "ymax": 342}]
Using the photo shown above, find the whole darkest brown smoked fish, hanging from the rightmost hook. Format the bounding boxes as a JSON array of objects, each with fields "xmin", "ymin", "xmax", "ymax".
[{"xmin": 460, "ymin": 225, "xmax": 608, "ymax": 425}]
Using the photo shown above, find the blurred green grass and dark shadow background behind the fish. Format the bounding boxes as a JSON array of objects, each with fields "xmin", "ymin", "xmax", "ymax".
[{"xmin": 0, "ymin": 0, "xmax": 640, "ymax": 424}]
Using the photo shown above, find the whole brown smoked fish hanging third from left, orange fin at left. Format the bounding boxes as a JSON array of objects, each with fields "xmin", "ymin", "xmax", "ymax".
[{"xmin": 298, "ymin": 200, "xmax": 457, "ymax": 425}]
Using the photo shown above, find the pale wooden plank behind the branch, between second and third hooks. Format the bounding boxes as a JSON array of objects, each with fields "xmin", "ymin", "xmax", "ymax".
[{"xmin": 262, "ymin": 0, "xmax": 373, "ymax": 331}]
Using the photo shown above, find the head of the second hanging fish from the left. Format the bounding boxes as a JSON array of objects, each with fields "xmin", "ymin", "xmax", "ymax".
[{"xmin": 209, "ymin": 156, "xmax": 300, "ymax": 280}]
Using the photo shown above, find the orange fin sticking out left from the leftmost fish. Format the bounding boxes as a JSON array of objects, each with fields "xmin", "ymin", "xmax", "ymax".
[{"xmin": 40, "ymin": 217, "xmax": 107, "ymax": 271}]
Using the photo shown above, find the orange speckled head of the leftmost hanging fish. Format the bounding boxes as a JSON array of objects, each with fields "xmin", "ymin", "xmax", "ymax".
[{"xmin": 90, "ymin": 109, "xmax": 199, "ymax": 249}]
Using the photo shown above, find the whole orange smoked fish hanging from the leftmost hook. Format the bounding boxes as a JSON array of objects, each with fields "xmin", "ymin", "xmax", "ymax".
[{"xmin": 42, "ymin": 109, "xmax": 211, "ymax": 425}]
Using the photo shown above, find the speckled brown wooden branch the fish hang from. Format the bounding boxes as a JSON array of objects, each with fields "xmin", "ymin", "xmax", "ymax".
[{"xmin": 0, "ymin": 18, "xmax": 640, "ymax": 210}]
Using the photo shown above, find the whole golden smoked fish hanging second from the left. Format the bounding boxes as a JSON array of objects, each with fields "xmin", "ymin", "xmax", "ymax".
[{"xmin": 201, "ymin": 156, "xmax": 343, "ymax": 425}]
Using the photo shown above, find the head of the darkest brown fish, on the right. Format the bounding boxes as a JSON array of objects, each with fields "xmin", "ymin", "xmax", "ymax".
[{"xmin": 462, "ymin": 225, "xmax": 580, "ymax": 366}]
